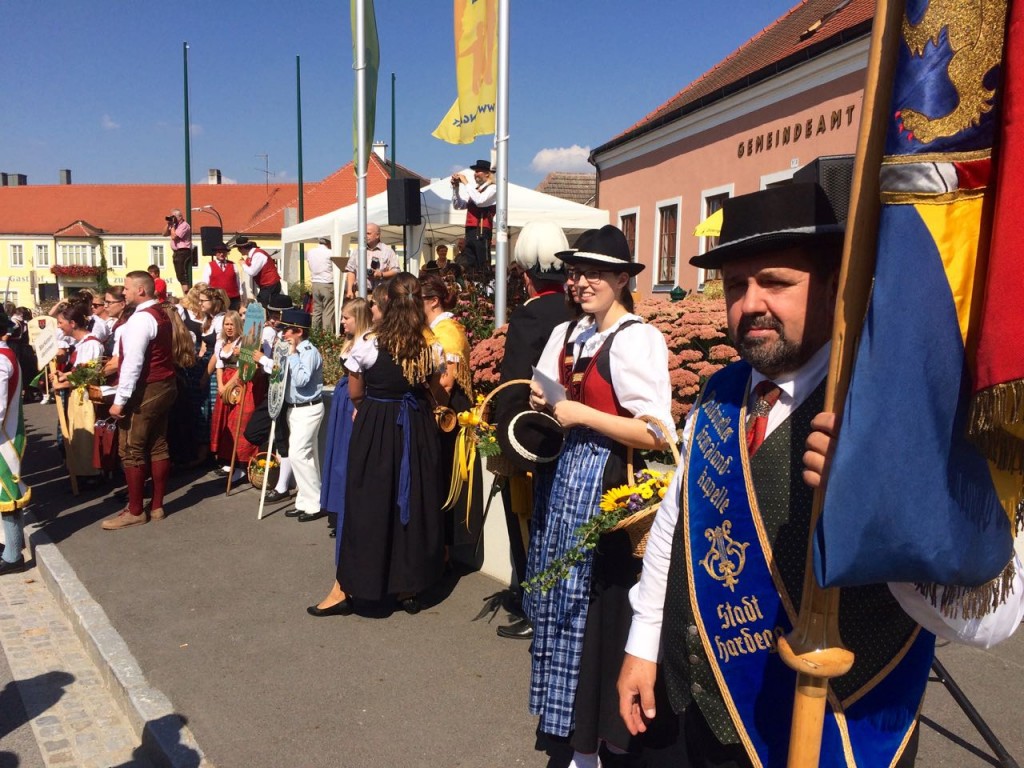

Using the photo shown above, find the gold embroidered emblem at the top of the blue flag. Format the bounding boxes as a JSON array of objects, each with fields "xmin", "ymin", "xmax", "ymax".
[{"xmin": 896, "ymin": 0, "xmax": 1007, "ymax": 144}]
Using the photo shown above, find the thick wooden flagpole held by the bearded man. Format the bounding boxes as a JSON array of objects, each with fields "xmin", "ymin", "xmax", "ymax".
[{"xmin": 778, "ymin": 0, "xmax": 905, "ymax": 768}]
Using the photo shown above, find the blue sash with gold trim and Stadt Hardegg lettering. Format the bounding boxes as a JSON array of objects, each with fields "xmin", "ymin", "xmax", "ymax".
[{"xmin": 682, "ymin": 364, "xmax": 934, "ymax": 767}]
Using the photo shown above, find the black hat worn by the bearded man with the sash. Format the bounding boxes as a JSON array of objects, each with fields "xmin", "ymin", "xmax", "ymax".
[{"xmin": 690, "ymin": 182, "xmax": 845, "ymax": 269}]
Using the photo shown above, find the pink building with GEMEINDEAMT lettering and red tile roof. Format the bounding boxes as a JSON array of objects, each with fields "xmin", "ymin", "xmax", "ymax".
[{"xmin": 591, "ymin": 0, "xmax": 874, "ymax": 293}]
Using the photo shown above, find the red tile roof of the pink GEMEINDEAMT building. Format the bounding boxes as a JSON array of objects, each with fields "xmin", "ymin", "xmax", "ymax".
[{"xmin": 591, "ymin": 0, "xmax": 874, "ymax": 157}]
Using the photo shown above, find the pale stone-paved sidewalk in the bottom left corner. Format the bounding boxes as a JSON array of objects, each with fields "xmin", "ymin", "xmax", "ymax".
[{"xmin": 0, "ymin": 568, "xmax": 148, "ymax": 768}]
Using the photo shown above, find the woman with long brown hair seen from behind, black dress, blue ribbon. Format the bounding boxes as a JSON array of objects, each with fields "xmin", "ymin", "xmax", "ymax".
[{"xmin": 307, "ymin": 272, "xmax": 444, "ymax": 616}]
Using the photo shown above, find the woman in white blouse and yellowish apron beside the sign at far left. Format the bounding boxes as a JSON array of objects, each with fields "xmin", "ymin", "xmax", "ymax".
[{"xmin": 52, "ymin": 302, "xmax": 105, "ymax": 484}]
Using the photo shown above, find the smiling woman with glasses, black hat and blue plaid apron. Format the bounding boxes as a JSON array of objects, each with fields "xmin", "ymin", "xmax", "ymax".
[{"xmin": 523, "ymin": 225, "xmax": 675, "ymax": 766}]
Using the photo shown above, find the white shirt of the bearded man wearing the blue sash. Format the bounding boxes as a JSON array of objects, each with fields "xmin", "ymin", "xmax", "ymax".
[{"xmin": 626, "ymin": 344, "xmax": 1024, "ymax": 662}]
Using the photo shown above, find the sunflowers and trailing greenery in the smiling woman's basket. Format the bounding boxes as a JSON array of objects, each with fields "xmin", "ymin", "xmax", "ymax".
[{"xmin": 522, "ymin": 469, "xmax": 674, "ymax": 592}]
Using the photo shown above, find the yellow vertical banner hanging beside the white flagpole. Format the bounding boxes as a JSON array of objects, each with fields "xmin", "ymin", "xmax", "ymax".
[{"xmin": 431, "ymin": 0, "xmax": 498, "ymax": 144}]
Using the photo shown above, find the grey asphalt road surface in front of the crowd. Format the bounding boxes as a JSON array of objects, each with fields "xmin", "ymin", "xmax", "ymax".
[{"xmin": 9, "ymin": 406, "xmax": 1024, "ymax": 768}]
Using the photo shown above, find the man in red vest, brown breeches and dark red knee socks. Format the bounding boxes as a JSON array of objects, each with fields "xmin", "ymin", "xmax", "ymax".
[{"xmin": 103, "ymin": 271, "xmax": 178, "ymax": 530}]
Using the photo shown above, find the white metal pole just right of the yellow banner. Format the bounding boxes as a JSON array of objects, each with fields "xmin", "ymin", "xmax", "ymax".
[{"xmin": 495, "ymin": 0, "xmax": 509, "ymax": 328}]
